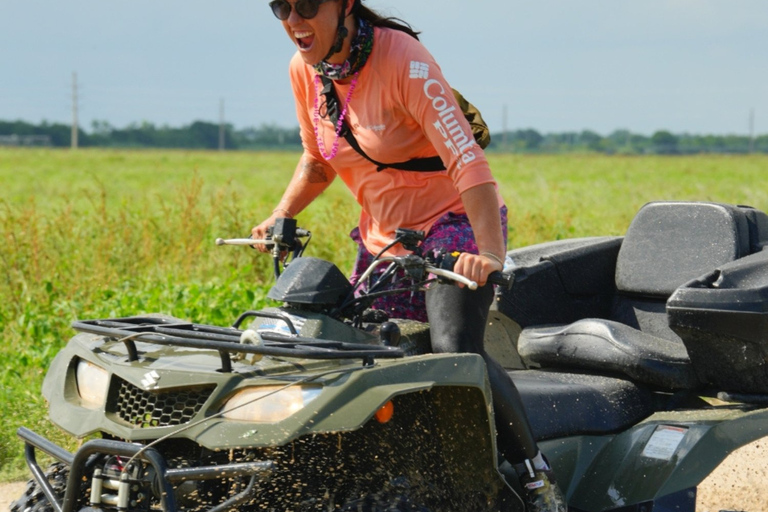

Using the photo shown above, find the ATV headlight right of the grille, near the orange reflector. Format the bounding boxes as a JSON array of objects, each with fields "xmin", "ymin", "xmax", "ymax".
[{"xmin": 222, "ymin": 386, "xmax": 322, "ymax": 423}]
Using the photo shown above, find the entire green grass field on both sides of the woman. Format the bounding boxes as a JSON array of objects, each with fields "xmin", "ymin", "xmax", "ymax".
[{"xmin": 0, "ymin": 149, "xmax": 768, "ymax": 480}]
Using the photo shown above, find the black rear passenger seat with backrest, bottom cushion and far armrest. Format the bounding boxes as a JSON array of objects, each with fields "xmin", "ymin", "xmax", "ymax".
[{"xmin": 498, "ymin": 202, "xmax": 768, "ymax": 390}]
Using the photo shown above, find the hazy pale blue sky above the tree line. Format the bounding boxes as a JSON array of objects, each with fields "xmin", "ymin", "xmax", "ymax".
[{"xmin": 0, "ymin": 0, "xmax": 768, "ymax": 134}]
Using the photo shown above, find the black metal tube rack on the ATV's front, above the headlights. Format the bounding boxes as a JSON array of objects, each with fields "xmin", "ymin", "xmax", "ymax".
[{"xmin": 72, "ymin": 312, "xmax": 405, "ymax": 373}]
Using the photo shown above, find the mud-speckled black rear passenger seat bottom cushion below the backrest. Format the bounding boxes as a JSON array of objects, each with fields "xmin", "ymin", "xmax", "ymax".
[{"xmin": 517, "ymin": 318, "xmax": 698, "ymax": 389}]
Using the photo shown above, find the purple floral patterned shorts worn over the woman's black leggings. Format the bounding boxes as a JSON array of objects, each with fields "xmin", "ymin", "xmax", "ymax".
[{"xmin": 349, "ymin": 206, "xmax": 508, "ymax": 322}]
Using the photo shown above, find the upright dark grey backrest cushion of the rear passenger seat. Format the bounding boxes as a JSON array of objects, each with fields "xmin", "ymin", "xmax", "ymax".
[{"xmin": 616, "ymin": 202, "xmax": 750, "ymax": 299}]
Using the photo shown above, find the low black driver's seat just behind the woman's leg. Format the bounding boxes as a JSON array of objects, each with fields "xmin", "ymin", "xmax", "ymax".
[{"xmin": 509, "ymin": 370, "xmax": 654, "ymax": 441}]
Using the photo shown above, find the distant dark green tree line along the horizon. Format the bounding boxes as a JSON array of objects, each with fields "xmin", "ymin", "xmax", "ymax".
[{"xmin": 0, "ymin": 121, "xmax": 768, "ymax": 155}]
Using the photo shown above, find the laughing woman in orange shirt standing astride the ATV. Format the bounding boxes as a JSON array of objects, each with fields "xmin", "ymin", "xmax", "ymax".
[{"xmin": 252, "ymin": 0, "xmax": 566, "ymax": 512}]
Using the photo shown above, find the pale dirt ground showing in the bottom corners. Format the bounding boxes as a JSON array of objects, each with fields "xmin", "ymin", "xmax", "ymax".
[{"xmin": 0, "ymin": 438, "xmax": 768, "ymax": 512}]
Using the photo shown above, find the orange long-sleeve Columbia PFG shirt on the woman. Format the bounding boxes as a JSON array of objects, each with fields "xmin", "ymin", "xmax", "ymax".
[{"xmin": 290, "ymin": 28, "xmax": 503, "ymax": 254}]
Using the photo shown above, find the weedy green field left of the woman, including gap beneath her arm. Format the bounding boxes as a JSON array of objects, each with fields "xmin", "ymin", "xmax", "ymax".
[{"xmin": 0, "ymin": 150, "xmax": 358, "ymax": 478}]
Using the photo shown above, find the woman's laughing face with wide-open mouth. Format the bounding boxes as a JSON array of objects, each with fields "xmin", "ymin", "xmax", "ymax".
[{"xmin": 282, "ymin": 0, "xmax": 343, "ymax": 66}]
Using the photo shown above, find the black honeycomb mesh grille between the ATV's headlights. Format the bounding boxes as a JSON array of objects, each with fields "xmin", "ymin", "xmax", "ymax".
[{"xmin": 115, "ymin": 378, "xmax": 215, "ymax": 428}]
